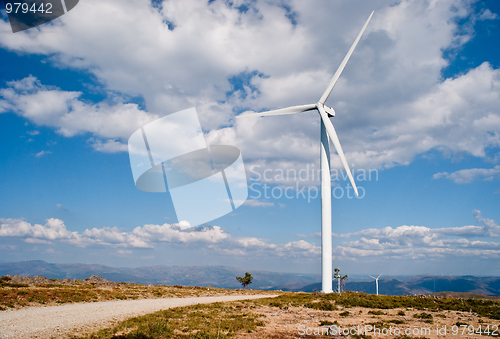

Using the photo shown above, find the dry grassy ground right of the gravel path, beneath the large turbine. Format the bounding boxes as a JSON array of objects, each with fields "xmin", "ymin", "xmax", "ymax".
[{"xmin": 70, "ymin": 292, "xmax": 500, "ymax": 339}]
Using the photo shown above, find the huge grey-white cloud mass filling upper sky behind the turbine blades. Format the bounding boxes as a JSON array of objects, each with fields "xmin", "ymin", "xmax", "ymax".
[{"xmin": 0, "ymin": 0, "xmax": 500, "ymax": 169}]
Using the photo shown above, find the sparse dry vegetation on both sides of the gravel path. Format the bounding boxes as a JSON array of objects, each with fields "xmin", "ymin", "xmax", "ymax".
[{"xmin": 0, "ymin": 278, "xmax": 500, "ymax": 339}]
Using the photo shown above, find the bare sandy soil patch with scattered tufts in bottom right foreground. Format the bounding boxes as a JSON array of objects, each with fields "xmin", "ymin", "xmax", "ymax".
[{"xmin": 238, "ymin": 306, "xmax": 500, "ymax": 339}]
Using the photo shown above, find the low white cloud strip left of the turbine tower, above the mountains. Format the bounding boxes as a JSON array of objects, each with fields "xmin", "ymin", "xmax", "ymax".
[{"xmin": 0, "ymin": 218, "xmax": 304, "ymax": 256}]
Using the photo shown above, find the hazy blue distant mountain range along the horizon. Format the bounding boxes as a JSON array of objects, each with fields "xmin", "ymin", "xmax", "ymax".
[{"xmin": 0, "ymin": 260, "xmax": 500, "ymax": 296}]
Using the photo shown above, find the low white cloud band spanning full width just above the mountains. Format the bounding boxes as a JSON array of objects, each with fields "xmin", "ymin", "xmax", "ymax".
[{"xmin": 0, "ymin": 210, "xmax": 500, "ymax": 260}]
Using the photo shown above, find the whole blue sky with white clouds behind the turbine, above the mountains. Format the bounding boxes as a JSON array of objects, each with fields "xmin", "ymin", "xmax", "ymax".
[{"xmin": 0, "ymin": 0, "xmax": 500, "ymax": 275}]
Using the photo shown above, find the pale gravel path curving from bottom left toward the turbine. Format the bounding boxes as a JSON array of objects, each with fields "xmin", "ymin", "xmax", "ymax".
[{"xmin": 0, "ymin": 295, "xmax": 276, "ymax": 339}]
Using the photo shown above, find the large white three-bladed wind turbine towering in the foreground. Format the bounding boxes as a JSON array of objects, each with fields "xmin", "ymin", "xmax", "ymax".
[{"xmin": 238, "ymin": 12, "xmax": 374, "ymax": 293}]
